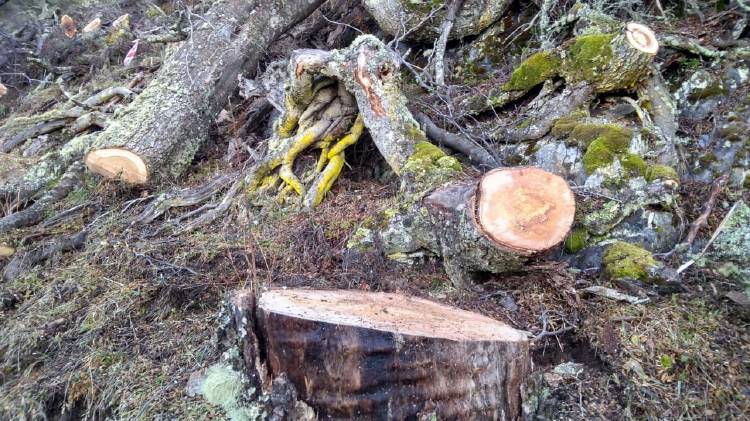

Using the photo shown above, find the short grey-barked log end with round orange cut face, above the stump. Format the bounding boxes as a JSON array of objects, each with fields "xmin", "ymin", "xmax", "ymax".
[{"xmin": 423, "ymin": 167, "xmax": 575, "ymax": 286}]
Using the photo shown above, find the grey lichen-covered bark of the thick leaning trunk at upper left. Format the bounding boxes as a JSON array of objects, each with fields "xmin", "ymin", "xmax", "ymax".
[{"xmin": 85, "ymin": 0, "xmax": 322, "ymax": 182}]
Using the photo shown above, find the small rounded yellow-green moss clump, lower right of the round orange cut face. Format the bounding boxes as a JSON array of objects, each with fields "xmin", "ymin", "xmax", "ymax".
[{"xmin": 602, "ymin": 241, "xmax": 657, "ymax": 281}]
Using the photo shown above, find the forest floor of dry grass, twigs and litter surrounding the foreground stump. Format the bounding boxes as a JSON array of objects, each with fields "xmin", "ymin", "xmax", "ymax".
[{"xmin": 0, "ymin": 0, "xmax": 750, "ymax": 420}]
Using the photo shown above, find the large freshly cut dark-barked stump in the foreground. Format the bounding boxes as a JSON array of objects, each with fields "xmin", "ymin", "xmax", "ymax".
[{"xmin": 245, "ymin": 290, "xmax": 531, "ymax": 420}]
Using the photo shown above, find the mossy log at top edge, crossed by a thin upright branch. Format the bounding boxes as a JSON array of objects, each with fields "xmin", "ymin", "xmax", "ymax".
[{"xmin": 362, "ymin": 0, "xmax": 512, "ymax": 43}]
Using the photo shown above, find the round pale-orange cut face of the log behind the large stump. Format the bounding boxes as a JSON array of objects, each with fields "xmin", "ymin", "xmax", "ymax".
[{"xmin": 476, "ymin": 167, "xmax": 575, "ymax": 253}]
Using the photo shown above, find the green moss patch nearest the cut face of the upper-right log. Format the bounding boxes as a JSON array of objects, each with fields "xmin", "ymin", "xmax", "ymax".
[{"xmin": 564, "ymin": 34, "xmax": 614, "ymax": 82}]
